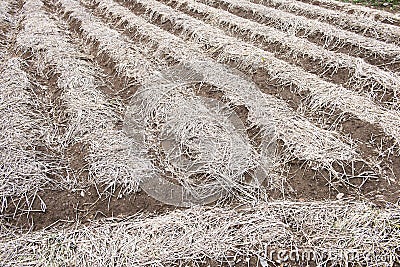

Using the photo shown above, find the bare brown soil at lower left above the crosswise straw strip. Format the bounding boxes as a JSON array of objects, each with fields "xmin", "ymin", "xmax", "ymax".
[{"xmin": 3, "ymin": 187, "xmax": 176, "ymax": 230}]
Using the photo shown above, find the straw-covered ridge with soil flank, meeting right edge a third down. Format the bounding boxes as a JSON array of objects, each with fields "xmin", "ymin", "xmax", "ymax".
[{"xmin": 175, "ymin": 0, "xmax": 400, "ymax": 103}]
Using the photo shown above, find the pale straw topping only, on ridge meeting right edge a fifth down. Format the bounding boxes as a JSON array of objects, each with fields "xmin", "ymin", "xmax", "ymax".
[{"xmin": 201, "ymin": 0, "xmax": 400, "ymax": 61}]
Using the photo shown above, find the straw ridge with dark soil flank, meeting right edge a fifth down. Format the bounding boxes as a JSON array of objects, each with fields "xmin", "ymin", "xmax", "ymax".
[{"xmin": 202, "ymin": 0, "xmax": 400, "ymax": 68}]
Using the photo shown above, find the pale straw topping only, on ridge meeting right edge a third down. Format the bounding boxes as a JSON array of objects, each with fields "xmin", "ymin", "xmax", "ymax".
[{"xmin": 174, "ymin": 0, "xmax": 400, "ymax": 103}]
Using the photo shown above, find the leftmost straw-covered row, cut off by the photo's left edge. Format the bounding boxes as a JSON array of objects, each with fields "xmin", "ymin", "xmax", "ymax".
[{"xmin": 0, "ymin": 58, "xmax": 57, "ymax": 213}]
